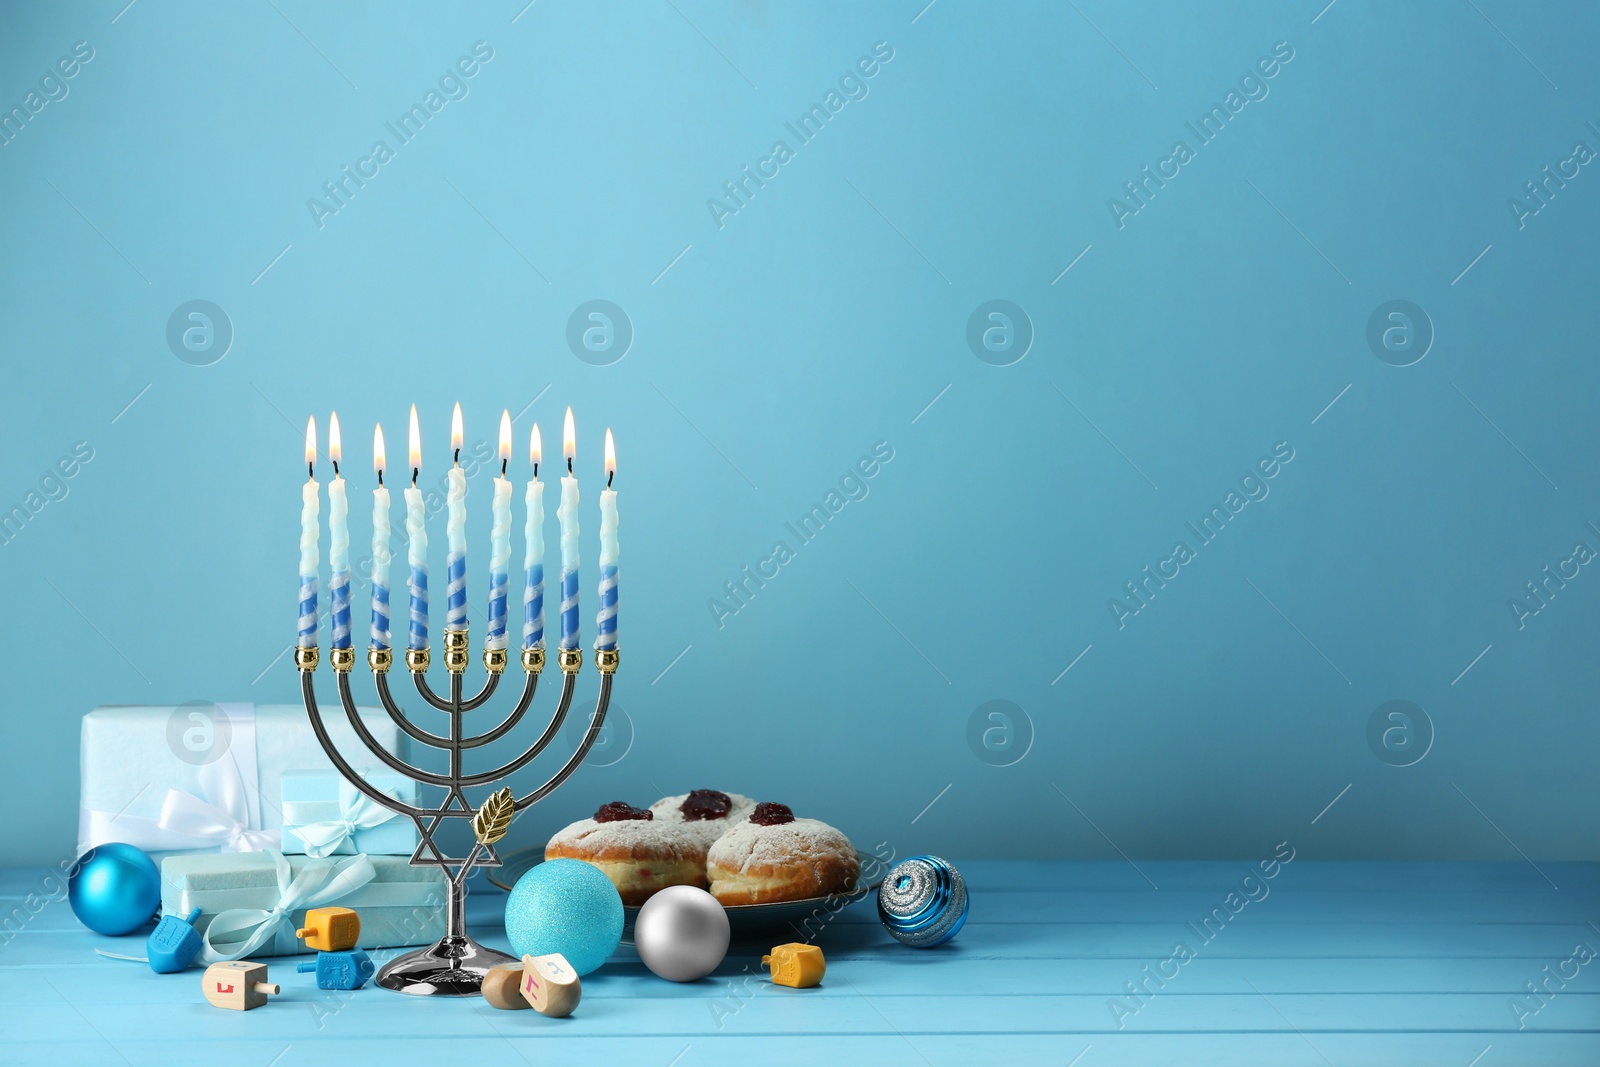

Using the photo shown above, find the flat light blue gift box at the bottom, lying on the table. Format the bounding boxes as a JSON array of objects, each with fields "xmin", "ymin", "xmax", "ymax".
[{"xmin": 162, "ymin": 849, "xmax": 450, "ymax": 963}]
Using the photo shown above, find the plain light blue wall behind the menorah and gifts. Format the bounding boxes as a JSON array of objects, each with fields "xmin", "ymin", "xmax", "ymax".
[{"xmin": 0, "ymin": 0, "xmax": 1600, "ymax": 862}]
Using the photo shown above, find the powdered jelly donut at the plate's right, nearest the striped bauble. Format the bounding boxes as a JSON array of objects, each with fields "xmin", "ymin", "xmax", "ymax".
[{"xmin": 706, "ymin": 803, "xmax": 861, "ymax": 905}]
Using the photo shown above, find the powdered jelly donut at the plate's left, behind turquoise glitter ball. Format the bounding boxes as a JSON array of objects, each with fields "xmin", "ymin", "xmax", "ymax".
[{"xmin": 544, "ymin": 800, "xmax": 706, "ymax": 907}]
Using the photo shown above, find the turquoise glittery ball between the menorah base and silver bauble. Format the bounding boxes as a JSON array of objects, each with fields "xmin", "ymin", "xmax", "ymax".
[{"xmin": 506, "ymin": 859, "xmax": 622, "ymax": 974}]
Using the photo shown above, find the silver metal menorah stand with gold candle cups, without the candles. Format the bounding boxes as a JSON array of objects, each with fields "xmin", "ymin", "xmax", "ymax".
[{"xmin": 294, "ymin": 629, "xmax": 618, "ymax": 997}]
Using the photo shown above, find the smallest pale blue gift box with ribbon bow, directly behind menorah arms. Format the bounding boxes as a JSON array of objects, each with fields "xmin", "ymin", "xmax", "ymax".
[{"xmin": 280, "ymin": 771, "xmax": 418, "ymax": 856}]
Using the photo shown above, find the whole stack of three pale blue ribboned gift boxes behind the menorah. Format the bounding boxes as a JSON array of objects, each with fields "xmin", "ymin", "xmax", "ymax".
[{"xmin": 78, "ymin": 704, "xmax": 448, "ymax": 963}]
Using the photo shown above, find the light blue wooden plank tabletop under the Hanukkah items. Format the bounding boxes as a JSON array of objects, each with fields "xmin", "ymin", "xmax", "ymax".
[{"xmin": 0, "ymin": 859, "xmax": 1600, "ymax": 1067}]
